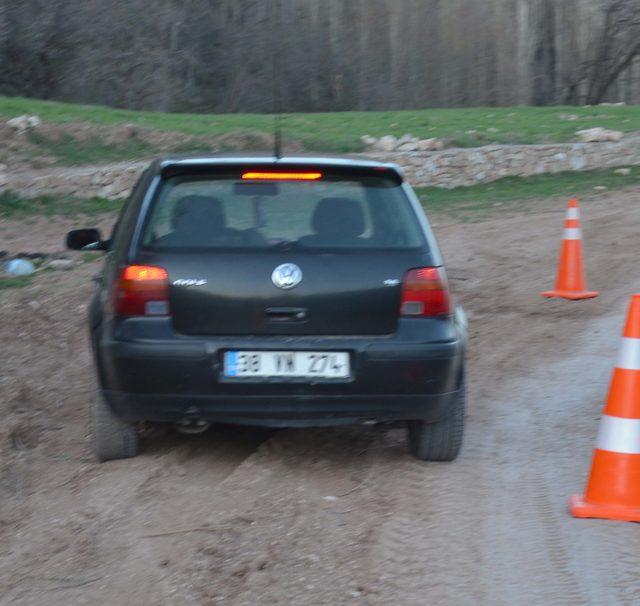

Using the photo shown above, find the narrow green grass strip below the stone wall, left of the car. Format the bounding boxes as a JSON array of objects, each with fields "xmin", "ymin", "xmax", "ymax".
[{"xmin": 0, "ymin": 192, "xmax": 124, "ymax": 219}]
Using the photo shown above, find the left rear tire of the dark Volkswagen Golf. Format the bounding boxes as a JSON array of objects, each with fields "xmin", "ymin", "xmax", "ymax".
[{"xmin": 92, "ymin": 394, "xmax": 140, "ymax": 462}]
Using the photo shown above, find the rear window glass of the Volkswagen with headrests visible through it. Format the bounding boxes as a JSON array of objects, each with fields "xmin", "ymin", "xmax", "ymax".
[{"xmin": 142, "ymin": 170, "xmax": 425, "ymax": 251}]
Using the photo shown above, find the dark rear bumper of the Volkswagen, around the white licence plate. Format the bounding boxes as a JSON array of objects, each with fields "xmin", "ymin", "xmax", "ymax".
[{"xmin": 96, "ymin": 319, "xmax": 466, "ymax": 426}]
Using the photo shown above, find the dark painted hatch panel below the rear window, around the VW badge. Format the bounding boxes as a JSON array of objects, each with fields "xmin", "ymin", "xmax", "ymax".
[{"xmin": 139, "ymin": 252, "xmax": 424, "ymax": 335}]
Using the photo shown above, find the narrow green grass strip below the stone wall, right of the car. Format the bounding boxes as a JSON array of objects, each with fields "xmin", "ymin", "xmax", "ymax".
[{"xmin": 416, "ymin": 167, "xmax": 640, "ymax": 218}]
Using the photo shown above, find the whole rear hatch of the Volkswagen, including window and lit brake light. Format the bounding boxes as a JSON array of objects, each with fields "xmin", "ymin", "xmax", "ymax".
[{"xmin": 137, "ymin": 163, "xmax": 432, "ymax": 335}]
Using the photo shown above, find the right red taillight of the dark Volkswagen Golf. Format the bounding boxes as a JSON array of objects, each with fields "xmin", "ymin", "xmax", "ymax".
[{"xmin": 400, "ymin": 267, "xmax": 451, "ymax": 317}]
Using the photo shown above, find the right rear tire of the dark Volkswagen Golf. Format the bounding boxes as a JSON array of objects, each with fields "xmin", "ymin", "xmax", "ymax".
[{"xmin": 407, "ymin": 383, "xmax": 467, "ymax": 461}]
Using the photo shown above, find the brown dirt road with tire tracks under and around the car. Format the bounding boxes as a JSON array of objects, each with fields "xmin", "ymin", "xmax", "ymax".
[{"xmin": 0, "ymin": 191, "xmax": 640, "ymax": 606}]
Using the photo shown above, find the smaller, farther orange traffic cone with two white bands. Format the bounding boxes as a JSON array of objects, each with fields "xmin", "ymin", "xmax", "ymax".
[{"xmin": 540, "ymin": 200, "xmax": 598, "ymax": 301}]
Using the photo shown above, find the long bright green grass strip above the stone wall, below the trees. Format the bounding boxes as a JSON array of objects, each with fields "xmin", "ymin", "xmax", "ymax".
[{"xmin": 0, "ymin": 97, "xmax": 640, "ymax": 160}]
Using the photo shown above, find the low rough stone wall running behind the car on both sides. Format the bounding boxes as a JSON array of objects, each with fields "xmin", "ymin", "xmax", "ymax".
[{"xmin": 0, "ymin": 135, "xmax": 640, "ymax": 198}]
